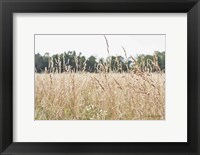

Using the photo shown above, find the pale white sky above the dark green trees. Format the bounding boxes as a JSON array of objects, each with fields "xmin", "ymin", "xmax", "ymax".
[{"xmin": 35, "ymin": 35, "xmax": 165, "ymax": 58}]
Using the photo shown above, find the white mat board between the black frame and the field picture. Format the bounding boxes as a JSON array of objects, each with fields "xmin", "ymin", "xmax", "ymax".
[{"xmin": 13, "ymin": 13, "xmax": 187, "ymax": 142}]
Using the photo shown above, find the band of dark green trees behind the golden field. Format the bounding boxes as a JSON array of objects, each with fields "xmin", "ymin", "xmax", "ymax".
[{"xmin": 35, "ymin": 51, "xmax": 165, "ymax": 73}]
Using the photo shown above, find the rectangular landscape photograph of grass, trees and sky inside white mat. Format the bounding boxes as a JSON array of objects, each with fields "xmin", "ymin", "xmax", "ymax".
[{"xmin": 34, "ymin": 34, "xmax": 166, "ymax": 120}]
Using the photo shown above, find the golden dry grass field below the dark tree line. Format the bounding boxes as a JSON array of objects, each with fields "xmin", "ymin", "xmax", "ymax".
[{"xmin": 35, "ymin": 72, "xmax": 165, "ymax": 120}]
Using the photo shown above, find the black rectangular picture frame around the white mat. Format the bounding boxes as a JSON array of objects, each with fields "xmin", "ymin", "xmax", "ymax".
[{"xmin": 0, "ymin": 0, "xmax": 200, "ymax": 155}]
